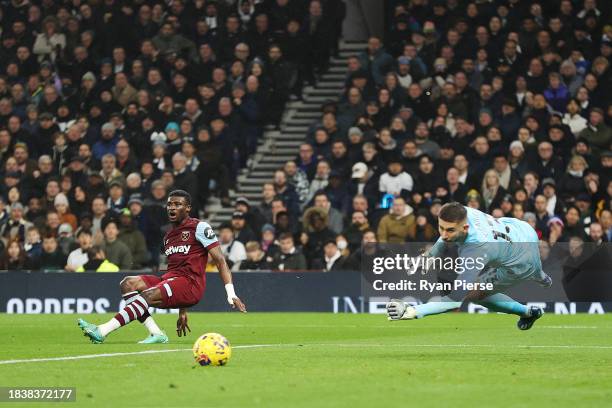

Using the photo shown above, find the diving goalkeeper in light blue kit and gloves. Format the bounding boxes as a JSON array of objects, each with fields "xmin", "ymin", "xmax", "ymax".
[{"xmin": 387, "ymin": 203, "xmax": 552, "ymax": 330}]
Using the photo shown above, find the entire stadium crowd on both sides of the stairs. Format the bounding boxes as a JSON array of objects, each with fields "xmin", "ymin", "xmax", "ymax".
[{"xmin": 0, "ymin": 0, "xmax": 612, "ymax": 271}]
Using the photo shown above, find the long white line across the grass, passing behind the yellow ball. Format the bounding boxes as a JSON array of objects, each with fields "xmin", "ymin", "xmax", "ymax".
[{"xmin": 0, "ymin": 343, "xmax": 612, "ymax": 365}]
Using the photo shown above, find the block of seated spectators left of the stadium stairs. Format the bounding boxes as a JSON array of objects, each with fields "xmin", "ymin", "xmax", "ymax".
[{"xmin": 0, "ymin": 0, "xmax": 344, "ymax": 271}]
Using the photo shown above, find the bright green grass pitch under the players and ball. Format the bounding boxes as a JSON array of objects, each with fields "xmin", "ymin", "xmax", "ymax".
[{"xmin": 0, "ymin": 313, "xmax": 612, "ymax": 408}]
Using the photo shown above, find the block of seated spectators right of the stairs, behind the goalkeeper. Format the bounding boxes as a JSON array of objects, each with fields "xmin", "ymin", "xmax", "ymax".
[{"xmin": 221, "ymin": 0, "xmax": 612, "ymax": 271}]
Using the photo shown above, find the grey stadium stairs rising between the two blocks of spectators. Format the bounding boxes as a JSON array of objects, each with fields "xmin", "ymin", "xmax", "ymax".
[{"xmin": 206, "ymin": 41, "xmax": 366, "ymax": 227}]
